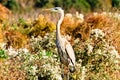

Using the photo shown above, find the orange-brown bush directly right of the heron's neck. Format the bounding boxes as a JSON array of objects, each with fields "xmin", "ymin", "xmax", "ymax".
[{"xmin": 61, "ymin": 14, "xmax": 91, "ymax": 41}]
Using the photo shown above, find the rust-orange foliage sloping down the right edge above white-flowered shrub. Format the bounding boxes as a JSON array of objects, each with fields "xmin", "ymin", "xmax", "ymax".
[{"xmin": 85, "ymin": 13, "xmax": 120, "ymax": 53}]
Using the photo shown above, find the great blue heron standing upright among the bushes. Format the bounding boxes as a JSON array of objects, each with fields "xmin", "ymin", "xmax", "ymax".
[{"xmin": 50, "ymin": 7, "xmax": 75, "ymax": 72}]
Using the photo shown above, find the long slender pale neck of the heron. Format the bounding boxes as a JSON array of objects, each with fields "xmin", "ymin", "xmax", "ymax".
[{"xmin": 56, "ymin": 11, "xmax": 64, "ymax": 39}]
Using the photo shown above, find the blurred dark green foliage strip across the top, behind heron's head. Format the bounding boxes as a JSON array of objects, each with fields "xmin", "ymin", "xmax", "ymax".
[{"xmin": 0, "ymin": 0, "xmax": 120, "ymax": 12}]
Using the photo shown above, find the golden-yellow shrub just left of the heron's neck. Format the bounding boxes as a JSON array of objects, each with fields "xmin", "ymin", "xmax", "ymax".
[{"xmin": 29, "ymin": 15, "xmax": 56, "ymax": 36}]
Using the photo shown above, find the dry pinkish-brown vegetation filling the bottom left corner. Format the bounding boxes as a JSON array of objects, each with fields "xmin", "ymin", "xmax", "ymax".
[{"xmin": 0, "ymin": 57, "xmax": 26, "ymax": 80}]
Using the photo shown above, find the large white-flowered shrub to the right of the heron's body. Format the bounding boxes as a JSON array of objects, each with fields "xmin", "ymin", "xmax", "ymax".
[{"xmin": 74, "ymin": 29, "xmax": 120, "ymax": 80}]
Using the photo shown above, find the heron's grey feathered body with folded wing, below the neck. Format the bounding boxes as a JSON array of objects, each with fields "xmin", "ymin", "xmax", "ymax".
[{"xmin": 57, "ymin": 38, "xmax": 75, "ymax": 67}]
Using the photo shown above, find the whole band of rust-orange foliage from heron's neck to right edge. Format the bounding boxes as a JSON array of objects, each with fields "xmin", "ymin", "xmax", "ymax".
[{"xmin": 61, "ymin": 13, "xmax": 120, "ymax": 53}]
